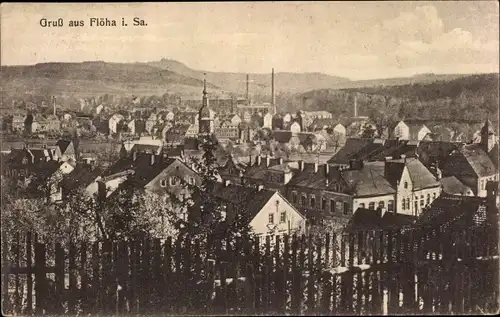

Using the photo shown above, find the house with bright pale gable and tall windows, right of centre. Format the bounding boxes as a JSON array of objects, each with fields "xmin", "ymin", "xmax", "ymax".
[{"xmin": 384, "ymin": 157, "xmax": 441, "ymax": 216}]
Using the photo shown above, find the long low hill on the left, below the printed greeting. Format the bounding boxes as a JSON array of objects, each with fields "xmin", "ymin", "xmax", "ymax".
[{"xmin": 1, "ymin": 62, "xmax": 220, "ymax": 100}]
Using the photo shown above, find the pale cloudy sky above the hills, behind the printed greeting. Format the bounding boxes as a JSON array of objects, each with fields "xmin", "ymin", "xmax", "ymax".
[{"xmin": 0, "ymin": 0, "xmax": 499, "ymax": 80}]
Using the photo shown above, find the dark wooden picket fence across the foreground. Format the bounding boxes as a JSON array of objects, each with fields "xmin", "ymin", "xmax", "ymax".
[{"xmin": 2, "ymin": 218, "xmax": 499, "ymax": 315}]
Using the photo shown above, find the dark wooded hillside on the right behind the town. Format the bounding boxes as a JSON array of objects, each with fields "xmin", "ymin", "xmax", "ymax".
[{"xmin": 285, "ymin": 74, "xmax": 499, "ymax": 122}]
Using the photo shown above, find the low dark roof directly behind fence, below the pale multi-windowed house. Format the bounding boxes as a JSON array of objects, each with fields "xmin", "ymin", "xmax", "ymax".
[{"xmin": 345, "ymin": 208, "xmax": 416, "ymax": 232}]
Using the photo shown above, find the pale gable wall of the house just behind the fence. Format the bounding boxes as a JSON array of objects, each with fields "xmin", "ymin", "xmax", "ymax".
[{"xmin": 250, "ymin": 193, "xmax": 305, "ymax": 235}]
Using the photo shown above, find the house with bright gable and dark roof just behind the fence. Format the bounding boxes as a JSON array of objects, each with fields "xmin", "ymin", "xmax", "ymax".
[{"xmin": 210, "ymin": 182, "xmax": 306, "ymax": 236}]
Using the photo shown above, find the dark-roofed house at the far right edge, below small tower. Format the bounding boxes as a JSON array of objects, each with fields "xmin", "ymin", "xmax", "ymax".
[{"xmin": 442, "ymin": 143, "xmax": 498, "ymax": 197}]
